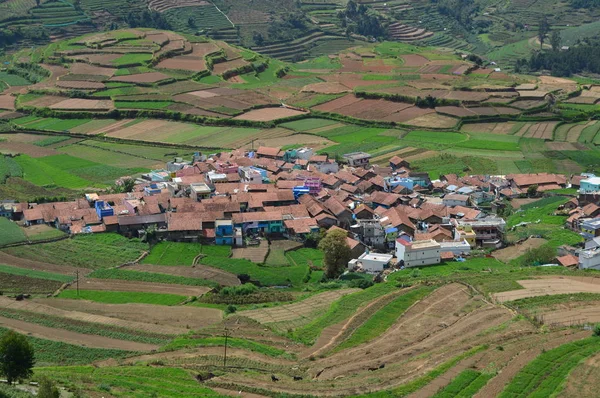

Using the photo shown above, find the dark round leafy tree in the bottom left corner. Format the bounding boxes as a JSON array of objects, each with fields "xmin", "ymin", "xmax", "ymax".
[{"xmin": 0, "ymin": 330, "xmax": 35, "ymax": 384}]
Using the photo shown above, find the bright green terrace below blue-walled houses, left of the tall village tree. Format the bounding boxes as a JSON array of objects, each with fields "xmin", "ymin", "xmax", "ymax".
[{"xmin": 200, "ymin": 255, "xmax": 308, "ymax": 286}]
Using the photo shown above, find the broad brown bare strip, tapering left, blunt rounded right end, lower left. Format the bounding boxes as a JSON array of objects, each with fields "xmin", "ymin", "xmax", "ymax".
[{"xmin": 33, "ymin": 298, "xmax": 223, "ymax": 331}]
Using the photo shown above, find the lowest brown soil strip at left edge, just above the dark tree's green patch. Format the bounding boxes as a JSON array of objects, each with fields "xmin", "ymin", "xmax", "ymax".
[{"xmin": 0, "ymin": 317, "xmax": 158, "ymax": 351}]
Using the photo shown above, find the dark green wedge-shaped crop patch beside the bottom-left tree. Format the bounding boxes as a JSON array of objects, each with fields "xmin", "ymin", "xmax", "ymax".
[{"xmin": 0, "ymin": 327, "xmax": 135, "ymax": 366}]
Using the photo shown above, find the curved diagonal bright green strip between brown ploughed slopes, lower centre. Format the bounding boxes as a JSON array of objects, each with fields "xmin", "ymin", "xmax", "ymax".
[{"xmin": 335, "ymin": 286, "xmax": 434, "ymax": 351}]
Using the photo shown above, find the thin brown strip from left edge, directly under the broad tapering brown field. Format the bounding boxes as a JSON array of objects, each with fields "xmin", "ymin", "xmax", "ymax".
[{"xmin": 0, "ymin": 297, "xmax": 189, "ymax": 335}]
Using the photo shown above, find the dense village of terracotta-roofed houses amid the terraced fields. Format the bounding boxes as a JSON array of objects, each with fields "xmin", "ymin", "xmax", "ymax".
[{"xmin": 0, "ymin": 147, "xmax": 588, "ymax": 272}]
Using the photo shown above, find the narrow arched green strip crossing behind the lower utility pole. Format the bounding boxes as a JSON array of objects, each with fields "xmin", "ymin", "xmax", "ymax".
[{"xmin": 162, "ymin": 336, "xmax": 291, "ymax": 358}]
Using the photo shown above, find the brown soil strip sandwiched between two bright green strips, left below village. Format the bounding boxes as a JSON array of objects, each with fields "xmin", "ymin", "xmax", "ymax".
[{"xmin": 70, "ymin": 278, "xmax": 211, "ymax": 296}]
